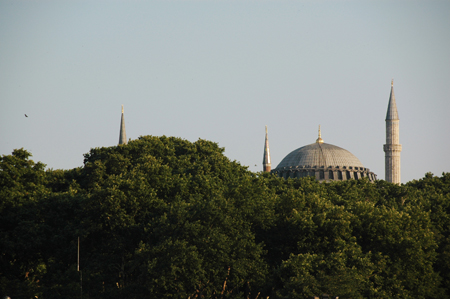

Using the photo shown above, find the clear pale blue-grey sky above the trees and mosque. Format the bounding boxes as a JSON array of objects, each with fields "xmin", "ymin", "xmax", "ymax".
[{"xmin": 0, "ymin": 0, "xmax": 450, "ymax": 183}]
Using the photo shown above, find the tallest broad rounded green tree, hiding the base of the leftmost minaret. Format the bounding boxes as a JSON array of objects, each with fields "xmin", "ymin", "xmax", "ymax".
[{"xmin": 71, "ymin": 136, "xmax": 267, "ymax": 298}]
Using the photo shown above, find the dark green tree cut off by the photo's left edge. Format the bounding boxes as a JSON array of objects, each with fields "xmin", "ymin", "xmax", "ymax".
[{"xmin": 0, "ymin": 149, "xmax": 50, "ymax": 297}]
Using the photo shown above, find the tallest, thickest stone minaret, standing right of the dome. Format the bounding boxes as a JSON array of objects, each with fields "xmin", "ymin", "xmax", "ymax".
[{"xmin": 384, "ymin": 79, "xmax": 402, "ymax": 185}]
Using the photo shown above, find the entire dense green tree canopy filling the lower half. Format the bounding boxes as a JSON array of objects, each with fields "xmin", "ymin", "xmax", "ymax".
[{"xmin": 0, "ymin": 136, "xmax": 450, "ymax": 299}]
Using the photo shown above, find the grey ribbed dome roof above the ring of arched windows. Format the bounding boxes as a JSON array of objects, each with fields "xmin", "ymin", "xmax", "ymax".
[{"xmin": 277, "ymin": 142, "xmax": 364, "ymax": 168}]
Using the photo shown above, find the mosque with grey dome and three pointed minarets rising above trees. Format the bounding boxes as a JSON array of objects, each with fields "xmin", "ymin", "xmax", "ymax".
[{"xmin": 119, "ymin": 80, "xmax": 402, "ymax": 184}]
